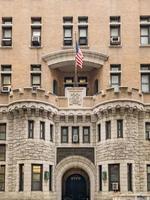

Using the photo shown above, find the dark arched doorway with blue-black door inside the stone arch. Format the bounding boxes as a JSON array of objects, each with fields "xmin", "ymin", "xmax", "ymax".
[{"xmin": 62, "ymin": 169, "xmax": 90, "ymax": 200}]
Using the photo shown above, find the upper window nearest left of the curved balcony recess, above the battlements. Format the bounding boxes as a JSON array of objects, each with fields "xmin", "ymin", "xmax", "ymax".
[{"xmin": 31, "ymin": 65, "xmax": 41, "ymax": 90}]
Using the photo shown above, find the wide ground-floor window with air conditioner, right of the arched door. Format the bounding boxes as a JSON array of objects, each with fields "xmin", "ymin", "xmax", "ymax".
[{"xmin": 108, "ymin": 164, "xmax": 120, "ymax": 191}]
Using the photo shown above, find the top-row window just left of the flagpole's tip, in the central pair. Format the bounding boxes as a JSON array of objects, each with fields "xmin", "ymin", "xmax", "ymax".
[{"xmin": 63, "ymin": 17, "xmax": 73, "ymax": 46}]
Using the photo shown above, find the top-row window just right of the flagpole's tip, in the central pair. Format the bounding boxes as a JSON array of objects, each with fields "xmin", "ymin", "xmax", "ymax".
[{"xmin": 78, "ymin": 17, "xmax": 88, "ymax": 45}]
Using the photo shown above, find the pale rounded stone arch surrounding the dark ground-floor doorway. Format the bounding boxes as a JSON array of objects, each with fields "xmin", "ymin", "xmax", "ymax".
[{"xmin": 55, "ymin": 156, "xmax": 96, "ymax": 200}]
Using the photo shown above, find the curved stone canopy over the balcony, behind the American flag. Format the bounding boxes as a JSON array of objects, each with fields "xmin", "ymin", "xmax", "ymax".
[{"xmin": 42, "ymin": 49, "xmax": 108, "ymax": 71}]
